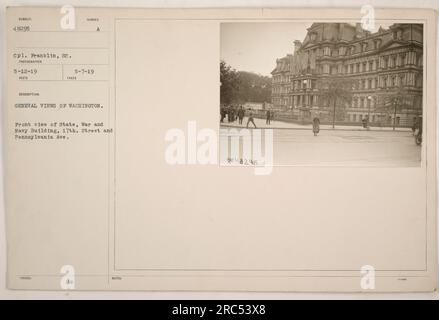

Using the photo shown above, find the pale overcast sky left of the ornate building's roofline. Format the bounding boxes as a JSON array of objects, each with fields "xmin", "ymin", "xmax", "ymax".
[{"xmin": 221, "ymin": 22, "xmax": 394, "ymax": 76}]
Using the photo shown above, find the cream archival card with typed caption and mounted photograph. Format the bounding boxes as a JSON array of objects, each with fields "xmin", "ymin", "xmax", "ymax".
[{"xmin": 3, "ymin": 6, "xmax": 437, "ymax": 292}]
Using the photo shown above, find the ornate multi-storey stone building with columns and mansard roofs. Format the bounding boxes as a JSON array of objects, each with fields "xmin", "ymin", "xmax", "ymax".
[{"xmin": 272, "ymin": 23, "xmax": 423, "ymax": 125}]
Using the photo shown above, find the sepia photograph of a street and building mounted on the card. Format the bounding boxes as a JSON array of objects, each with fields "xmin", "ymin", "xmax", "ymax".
[{"xmin": 219, "ymin": 21, "xmax": 424, "ymax": 167}]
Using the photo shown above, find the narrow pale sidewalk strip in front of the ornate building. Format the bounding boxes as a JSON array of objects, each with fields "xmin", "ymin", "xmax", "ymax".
[{"xmin": 220, "ymin": 117, "xmax": 412, "ymax": 132}]
